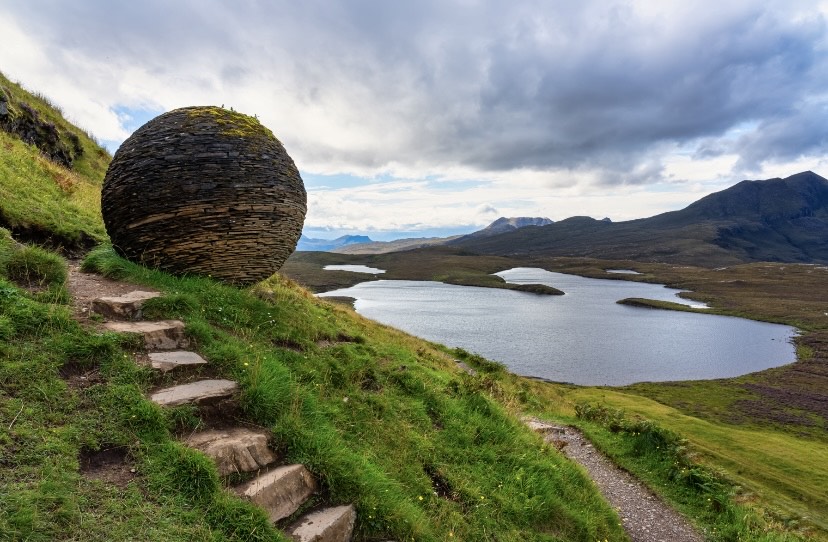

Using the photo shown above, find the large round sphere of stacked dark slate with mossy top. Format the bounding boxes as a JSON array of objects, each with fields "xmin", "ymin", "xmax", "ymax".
[{"xmin": 101, "ymin": 107, "xmax": 307, "ymax": 285}]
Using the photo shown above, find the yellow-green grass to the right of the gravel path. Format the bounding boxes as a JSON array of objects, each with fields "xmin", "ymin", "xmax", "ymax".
[{"xmin": 552, "ymin": 388, "xmax": 828, "ymax": 540}]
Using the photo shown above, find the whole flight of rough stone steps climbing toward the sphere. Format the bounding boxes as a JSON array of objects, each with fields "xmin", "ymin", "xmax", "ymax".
[{"xmin": 92, "ymin": 291, "xmax": 356, "ymax": 542}]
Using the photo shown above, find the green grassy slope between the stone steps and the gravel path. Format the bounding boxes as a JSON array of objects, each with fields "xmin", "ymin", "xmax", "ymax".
[{"xmin": 76, "ymin": 249, "xmax": 624, "ymax": 541}]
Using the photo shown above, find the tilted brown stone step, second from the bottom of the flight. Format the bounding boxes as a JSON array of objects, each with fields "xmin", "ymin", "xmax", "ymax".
[{"xmin": 237, "ymin": 465, "xmax": 316, "ymax": 523}]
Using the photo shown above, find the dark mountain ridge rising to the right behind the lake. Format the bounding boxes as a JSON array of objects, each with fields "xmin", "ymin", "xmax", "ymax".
[{"xmin": 451, "ymin": 171, "xmax": 828, "ymax": 266}]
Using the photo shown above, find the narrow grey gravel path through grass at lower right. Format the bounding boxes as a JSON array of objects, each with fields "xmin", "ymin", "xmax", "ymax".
[{"xmin": 526, "ymin": 420, "xmax": 704, "ymax": 542}]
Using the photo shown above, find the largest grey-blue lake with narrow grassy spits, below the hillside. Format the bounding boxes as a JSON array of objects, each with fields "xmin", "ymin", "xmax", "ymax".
[{"xmin": 321, "ymin": 268, "xmax": 796, "ymax": 385}]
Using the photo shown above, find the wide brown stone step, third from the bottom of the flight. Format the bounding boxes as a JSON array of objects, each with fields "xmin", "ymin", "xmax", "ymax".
[{"xmin": 185, "ymin": 427, "xmax": 276, "ymax": 476}]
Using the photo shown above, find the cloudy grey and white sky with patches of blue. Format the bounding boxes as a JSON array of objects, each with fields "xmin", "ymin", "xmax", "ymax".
[{"xmin": 0, "ymin": 0, "xmax": 828, "ymax": 239}]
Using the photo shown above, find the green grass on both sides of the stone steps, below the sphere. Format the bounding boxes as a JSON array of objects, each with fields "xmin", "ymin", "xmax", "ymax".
[{"xmin": 0, "ymin": 239, "xmax": 623, "ymax": 541}]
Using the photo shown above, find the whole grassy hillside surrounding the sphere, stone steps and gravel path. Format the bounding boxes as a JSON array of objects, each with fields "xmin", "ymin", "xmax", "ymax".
[{"xmin": 0, "ymin": 73, "xmax": 818, "ymax": 542}]
